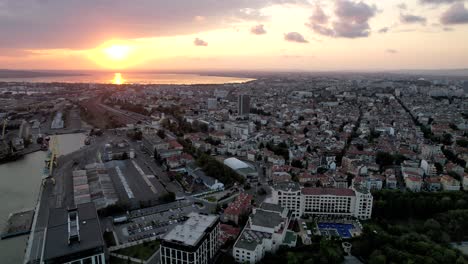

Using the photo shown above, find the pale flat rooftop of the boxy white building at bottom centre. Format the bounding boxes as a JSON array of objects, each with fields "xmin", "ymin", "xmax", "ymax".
[{"xmin": 163, "ymin": 212, "xmax": 218, "ymax": 246}]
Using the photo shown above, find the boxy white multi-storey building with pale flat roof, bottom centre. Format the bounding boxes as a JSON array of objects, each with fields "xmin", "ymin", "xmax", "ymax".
[{"xmin": 160, "ymin": 213, "xmax": 219, "ymax": 264}]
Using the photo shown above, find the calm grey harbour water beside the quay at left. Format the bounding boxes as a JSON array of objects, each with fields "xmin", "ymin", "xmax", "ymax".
[{"xmin": 0, "ymin": 134, "xmax": 85, "ymax": 263}]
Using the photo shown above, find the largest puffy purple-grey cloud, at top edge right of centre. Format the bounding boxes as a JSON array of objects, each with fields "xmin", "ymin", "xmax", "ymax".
[{"xmin": 306, "ymin": 0, "xmax": 377, "ymax": 38}]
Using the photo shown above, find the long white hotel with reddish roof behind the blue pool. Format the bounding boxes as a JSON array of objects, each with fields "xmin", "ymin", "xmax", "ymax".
[{"xmin": 270, "ymin": 182, "xmax": 373, "ymax": 220}]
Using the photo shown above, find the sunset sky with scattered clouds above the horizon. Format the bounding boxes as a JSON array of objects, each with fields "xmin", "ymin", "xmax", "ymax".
[{"xmin": 0, "ymin": 0, "xmax": 468, "ymax": 71}]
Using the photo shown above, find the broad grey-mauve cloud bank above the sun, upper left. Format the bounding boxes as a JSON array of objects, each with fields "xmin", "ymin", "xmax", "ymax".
[{"xmin": 0, "ymin": 0, "xmax": 306, "ymax": 49}]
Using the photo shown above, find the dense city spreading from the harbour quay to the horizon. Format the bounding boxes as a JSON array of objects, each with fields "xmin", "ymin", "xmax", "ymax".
[{"xmin": 0, "ymin": 73, "xmax": 468, "ymax": 263}]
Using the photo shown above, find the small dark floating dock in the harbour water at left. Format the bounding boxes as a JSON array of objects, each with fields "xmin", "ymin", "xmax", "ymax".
[{"xmin": 1, "ymin": 209, "xmax": 34, "ymax": 239}]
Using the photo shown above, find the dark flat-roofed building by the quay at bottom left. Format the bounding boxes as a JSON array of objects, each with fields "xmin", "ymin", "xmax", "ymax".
[{"xmin": 41, "ymin": 203, "xmax": 106, "ymax": 264}]
